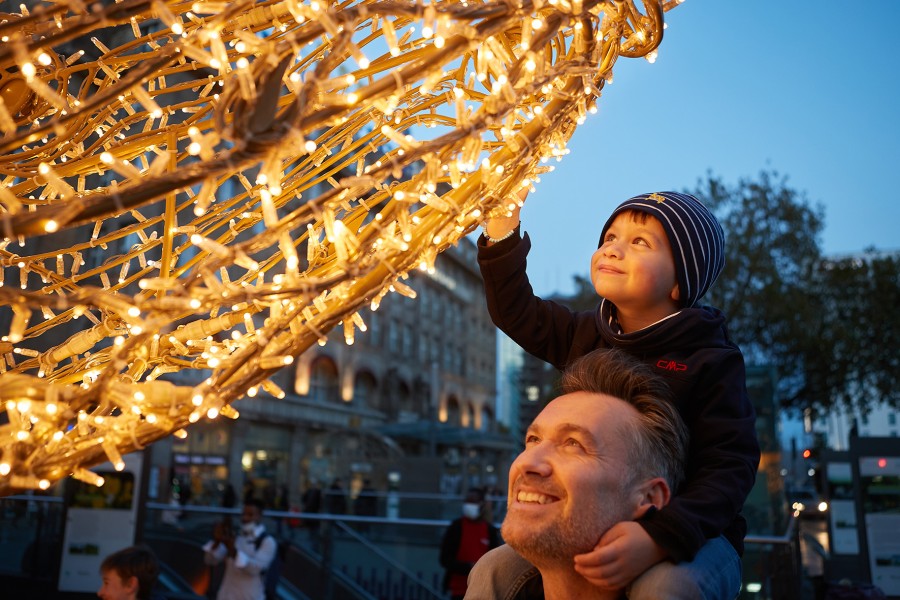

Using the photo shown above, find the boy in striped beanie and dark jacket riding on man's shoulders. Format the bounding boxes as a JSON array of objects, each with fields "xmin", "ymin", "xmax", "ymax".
[{"xmin": 467, "ymin": 192, "xmax": 759, "ymax": 600}]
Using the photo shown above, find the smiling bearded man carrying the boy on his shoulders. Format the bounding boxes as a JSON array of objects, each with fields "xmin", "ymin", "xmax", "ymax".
[{"xmin": 466, "ymin": 350, "xmax": 687, "ymax": 600}]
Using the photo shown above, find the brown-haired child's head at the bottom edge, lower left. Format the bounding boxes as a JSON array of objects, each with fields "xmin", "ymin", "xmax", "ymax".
[{"xmin": 97, "ymin": 546, "xmax": 159, "ymax": 600}]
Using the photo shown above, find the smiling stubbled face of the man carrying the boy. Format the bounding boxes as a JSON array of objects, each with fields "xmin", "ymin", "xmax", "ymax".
[{"xmin": 502, "ymin": 392, "xmax": 640, "ymax": 567}]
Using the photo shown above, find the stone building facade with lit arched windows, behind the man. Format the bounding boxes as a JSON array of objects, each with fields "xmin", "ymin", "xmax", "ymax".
[{"xmin": 151, "ymin": 240, "xmax": 518, "ymax": 516}]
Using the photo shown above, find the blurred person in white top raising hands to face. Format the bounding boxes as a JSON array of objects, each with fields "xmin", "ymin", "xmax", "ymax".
[{"xmin": 203, "ymin": 498, "xmax": 278, "ymax": 600}]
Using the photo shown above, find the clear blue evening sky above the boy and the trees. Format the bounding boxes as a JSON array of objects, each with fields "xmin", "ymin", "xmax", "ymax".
[{"xmin": 522, "ymin": 0, "xmax": 900, "ymax": 294}]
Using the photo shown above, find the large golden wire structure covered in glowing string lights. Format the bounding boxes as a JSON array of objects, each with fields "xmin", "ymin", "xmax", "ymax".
[{"xmin": 0, "ymin": 0, "xmax": 681, "ymax": 495}]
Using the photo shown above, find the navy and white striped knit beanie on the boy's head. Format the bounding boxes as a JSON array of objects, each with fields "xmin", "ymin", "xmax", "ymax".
[{"xmin": 600, "ymin": 192, "xmax": 725, "ymax": 308}]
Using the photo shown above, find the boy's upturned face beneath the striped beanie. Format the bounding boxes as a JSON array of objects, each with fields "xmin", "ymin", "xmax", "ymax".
[{"xmin": 591, "ymin": 211, "xmax": 678, "ymax": 323}]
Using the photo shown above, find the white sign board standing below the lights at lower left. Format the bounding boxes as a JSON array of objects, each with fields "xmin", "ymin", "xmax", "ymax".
[{"xmin": 59, "ymin": 452, "xmax": 143, "ymax": 592}]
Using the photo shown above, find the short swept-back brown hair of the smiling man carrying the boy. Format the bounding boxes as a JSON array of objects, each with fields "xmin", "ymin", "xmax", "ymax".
[{"xmin": 560, "ymin": 349, "xmax": 688, "ymax": 494}]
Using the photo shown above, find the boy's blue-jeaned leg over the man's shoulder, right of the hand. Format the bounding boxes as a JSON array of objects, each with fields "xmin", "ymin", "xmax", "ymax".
[{"xmin": 627, "ymin": 536, "xmax": 741, "ymax": 600}]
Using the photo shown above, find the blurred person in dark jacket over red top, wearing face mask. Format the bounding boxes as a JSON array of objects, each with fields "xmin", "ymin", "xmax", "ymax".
[{"xmin": 440, "ymin": 488, "xmax": 500, "ymax": 600}]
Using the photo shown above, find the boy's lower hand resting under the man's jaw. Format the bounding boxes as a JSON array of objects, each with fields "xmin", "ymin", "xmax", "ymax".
[{"xmin": 575, "ymin": 521, "xmax": 666, "ymax": 590}]
